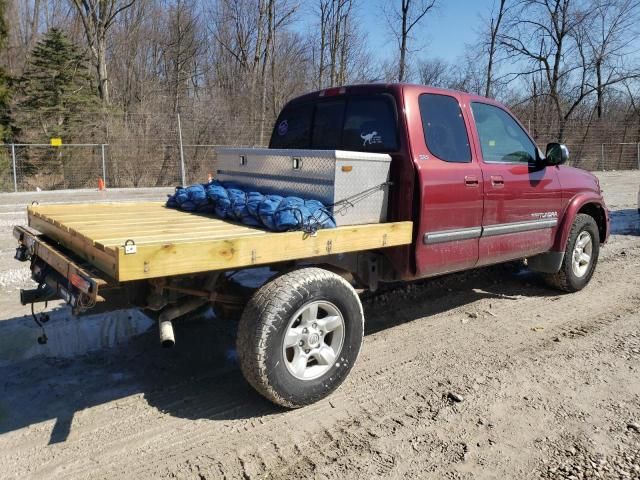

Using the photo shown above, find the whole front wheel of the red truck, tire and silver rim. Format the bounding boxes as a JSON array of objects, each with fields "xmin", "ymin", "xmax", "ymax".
[{"xmin": 545, "ymin": 213, "xmax": 600, "ymax": 292}]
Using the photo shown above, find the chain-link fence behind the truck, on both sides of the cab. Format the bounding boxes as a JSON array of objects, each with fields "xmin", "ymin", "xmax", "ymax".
[{"xmin": 0, "ymin": 109, "xmax": 640, "ymax": 192}]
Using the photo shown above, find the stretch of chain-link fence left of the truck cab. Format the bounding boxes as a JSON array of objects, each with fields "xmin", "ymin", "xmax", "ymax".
[{"xmin": 0, "ymin": 107, "xmax": 264, "ymax": 192}]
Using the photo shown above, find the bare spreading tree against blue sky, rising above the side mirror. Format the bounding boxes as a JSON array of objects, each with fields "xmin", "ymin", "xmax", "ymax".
[{"xmin": 498, "ymin": 0, "xmax": 638, "ymax": 141}]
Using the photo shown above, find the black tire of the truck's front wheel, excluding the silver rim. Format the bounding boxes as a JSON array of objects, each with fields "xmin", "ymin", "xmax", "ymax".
[{"xmin": 544, "ymin": 213, "xmax": 600, "ymax": 292}]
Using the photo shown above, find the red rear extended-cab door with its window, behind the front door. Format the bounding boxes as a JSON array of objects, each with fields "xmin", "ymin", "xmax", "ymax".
[{"xmin": 408, "ymin": 93, "xmax": 483, "ymax": 276}]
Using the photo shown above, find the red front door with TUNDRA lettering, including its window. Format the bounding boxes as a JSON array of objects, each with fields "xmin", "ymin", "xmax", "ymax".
[{"xmin": 471, "ymin": 102, "xmax": 562, "ymax": 265}]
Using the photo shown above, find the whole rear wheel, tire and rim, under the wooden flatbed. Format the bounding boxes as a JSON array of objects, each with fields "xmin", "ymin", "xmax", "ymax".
[{"xmin": 237, "ymin": 268, "xmax": 364, "ymax": 408}]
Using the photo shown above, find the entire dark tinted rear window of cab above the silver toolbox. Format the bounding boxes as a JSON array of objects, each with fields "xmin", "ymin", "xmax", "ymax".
[{"xmin": 270, "ymin": 95, "xmax": 398, "ymax": 152}]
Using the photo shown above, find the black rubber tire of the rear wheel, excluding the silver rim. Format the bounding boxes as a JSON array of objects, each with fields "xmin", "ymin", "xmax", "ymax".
[{"xmin": 237, "ymin": 267, "xmax": 364, "ymax": 408}]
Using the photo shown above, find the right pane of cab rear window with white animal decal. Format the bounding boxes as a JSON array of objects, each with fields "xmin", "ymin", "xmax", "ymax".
[{"xmin": 342, "ymin": 96, "xmax": 398, "ymax": 152}]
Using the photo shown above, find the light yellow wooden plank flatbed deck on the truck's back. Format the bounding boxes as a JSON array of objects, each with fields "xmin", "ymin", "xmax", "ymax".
[{"xmin": 28, "ymin": 202, "xmax": 412, "ymax": 282}]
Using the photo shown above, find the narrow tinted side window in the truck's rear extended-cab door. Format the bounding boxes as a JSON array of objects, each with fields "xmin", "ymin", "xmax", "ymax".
[{"xmin": 419, "ymin": 94, "xmax": 471, "ymax": 163}]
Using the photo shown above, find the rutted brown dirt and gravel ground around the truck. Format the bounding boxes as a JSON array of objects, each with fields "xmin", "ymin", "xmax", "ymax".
[{"xmin": 0, "ymin": 172, "xmax": 640, "ymax": 480}]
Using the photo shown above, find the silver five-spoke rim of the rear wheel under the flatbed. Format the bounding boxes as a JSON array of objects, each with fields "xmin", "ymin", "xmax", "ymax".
[{"xmin": 282, "ymin": 301, "xmax": 345, "ymax": 380}]
